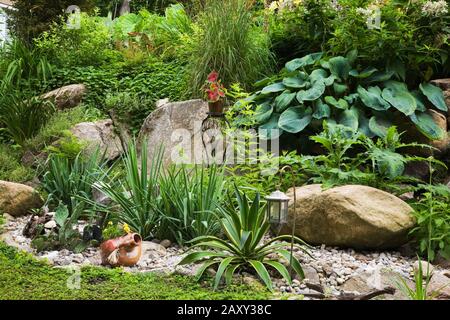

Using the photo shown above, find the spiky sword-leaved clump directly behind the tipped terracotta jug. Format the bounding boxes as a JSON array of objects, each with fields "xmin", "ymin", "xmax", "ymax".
[{"xmin": 94, "ymin": 141, "xmax": 163, "ymax": 239}]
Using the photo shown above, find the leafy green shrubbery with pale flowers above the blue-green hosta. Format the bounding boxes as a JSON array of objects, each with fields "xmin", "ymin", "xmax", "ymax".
[{"xmin": 268, "ymin": 0, "xmax": 450, "ymax": 85}]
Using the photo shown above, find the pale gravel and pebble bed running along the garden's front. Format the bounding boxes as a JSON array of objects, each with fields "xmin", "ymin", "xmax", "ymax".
[{"xmin": 1, "ymin": 216, "xmax": 450, "ymax": 299}]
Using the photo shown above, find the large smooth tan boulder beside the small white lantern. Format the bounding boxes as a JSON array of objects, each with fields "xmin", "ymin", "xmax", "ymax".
[{"xmin": 282, "ymin": 185, "xmax": 415, "ymax": 249}]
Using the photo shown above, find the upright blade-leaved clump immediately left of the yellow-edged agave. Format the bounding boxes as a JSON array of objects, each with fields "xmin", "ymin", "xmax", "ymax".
[{"xmin": 157, "ymin": 166, "xmax": 224, "ymax": 244}]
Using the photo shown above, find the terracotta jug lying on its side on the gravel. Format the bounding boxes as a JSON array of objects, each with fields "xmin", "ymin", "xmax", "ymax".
[{"xmin": 100, "ymin": 233, "xmax": 142, "ymax": 267}]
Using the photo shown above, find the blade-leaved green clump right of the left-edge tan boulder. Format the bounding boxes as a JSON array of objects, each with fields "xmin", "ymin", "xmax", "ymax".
[{"xmin": 42, "ymin": 150, "xmax": 108, "ymax": 214}]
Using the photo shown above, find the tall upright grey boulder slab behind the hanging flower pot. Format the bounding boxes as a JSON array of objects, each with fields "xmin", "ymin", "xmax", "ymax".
[{"xmin": 139, "ymin": 100, "xmax": 208, "ymax": 167}]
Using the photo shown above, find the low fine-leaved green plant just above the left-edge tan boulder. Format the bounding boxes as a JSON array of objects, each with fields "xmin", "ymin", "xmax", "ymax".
[{"xmin": 0, "ymin": 144, "xmax": 35, "ymax": 183}]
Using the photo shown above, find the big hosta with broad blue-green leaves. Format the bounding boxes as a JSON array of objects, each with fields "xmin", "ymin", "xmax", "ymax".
[{"xmin": 247, "ymin": 51, "xmax": 447, "ymax": 139}]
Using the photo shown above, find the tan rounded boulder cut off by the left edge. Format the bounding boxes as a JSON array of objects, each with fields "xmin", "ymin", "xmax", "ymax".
[{"xmin": 0, "ymin": 181, "xmax": 44, "ymax": 217}]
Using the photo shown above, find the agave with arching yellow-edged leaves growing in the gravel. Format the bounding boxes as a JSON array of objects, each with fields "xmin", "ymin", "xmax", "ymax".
[{"xmin": 179, "ymin": 186, "xmax": 307, "ymax": 290}]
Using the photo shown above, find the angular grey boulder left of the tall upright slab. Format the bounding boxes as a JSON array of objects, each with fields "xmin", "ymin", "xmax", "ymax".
[{"xmin": 70, "ymin": 119, "xmax": 123, "ymax": 160}]
